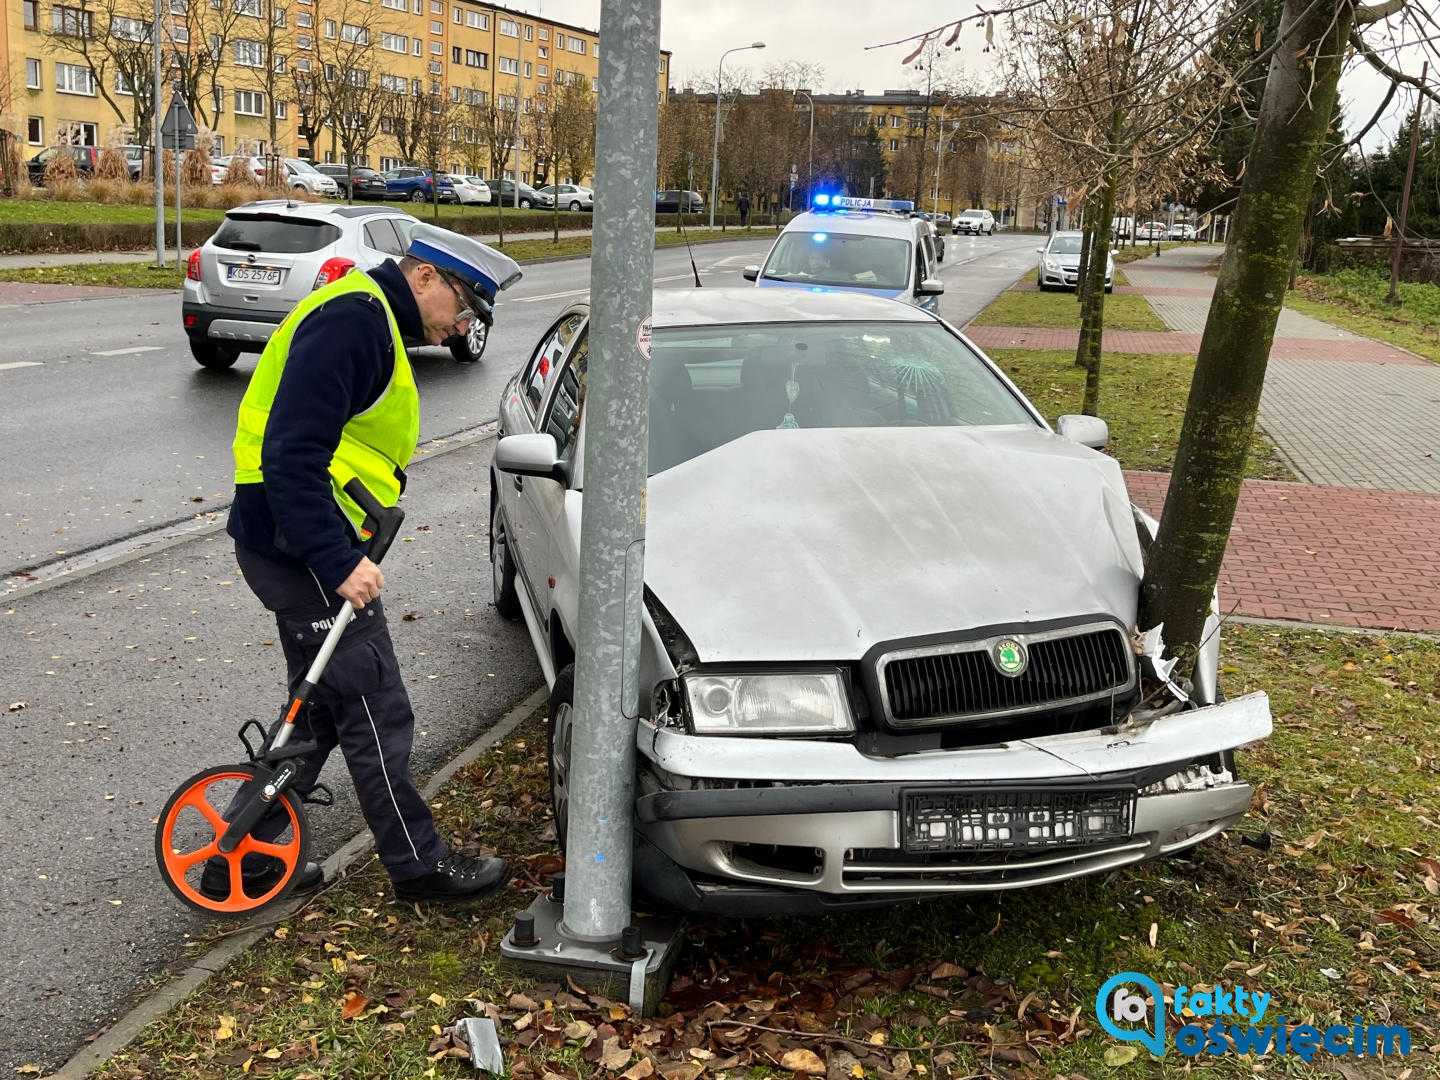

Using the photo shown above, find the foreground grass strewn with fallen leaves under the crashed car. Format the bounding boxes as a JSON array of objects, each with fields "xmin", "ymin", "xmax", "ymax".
[{"xmin": 90, "ymin": 626, "xmax": 1440, "ymax": 1080}]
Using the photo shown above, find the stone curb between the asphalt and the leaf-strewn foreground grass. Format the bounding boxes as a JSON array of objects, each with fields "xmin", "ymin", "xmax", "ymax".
[{"xmin": 50, "ymin": 687, "xmax": 550, "ymax": 1080}]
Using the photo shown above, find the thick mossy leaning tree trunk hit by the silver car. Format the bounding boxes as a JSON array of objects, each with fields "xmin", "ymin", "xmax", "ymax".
[{"xmin": 1139, "ymin": 0, "xmax": 1355, "ymax": 664}]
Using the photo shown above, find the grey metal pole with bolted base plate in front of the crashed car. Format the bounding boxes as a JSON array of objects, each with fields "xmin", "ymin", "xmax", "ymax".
[{"xmin": 501, "ymin": 0, "xmax": 678, "ymax": 1012}]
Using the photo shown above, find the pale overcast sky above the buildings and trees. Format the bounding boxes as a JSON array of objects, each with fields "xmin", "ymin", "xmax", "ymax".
[{"xmin": 508, "ymin": 0, "xmax": 1434, "ymax": 148}]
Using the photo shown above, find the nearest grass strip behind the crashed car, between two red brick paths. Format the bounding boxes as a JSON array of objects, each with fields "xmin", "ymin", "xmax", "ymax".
[{"xmin": 986, "ymin": 348, "xmax": 1296, "ymax": 480}]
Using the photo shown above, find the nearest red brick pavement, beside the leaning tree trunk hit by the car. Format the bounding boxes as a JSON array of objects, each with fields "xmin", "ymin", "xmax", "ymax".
[{"xmin": 1125, "ymin": 472, "xmax": 1440, "ymax": 631}]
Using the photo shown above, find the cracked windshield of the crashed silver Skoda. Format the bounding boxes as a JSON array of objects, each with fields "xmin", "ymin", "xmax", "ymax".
[{"xmin": 649, "ymin": 323, "xmax": 1034, "ymax": 475}]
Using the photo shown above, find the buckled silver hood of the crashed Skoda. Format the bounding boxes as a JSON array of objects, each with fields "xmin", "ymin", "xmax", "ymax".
[{"xmin": 645, "ymin": 428, "xmax": 1143, "ymax": 662}]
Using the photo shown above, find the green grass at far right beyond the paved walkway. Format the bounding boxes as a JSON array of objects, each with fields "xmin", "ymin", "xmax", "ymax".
[{"xmin": 1284, "ymin": 268, "xmax": 1440, "ymax": 363}]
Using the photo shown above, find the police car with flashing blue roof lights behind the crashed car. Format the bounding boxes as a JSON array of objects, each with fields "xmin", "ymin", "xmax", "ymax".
[{"xmin": 743, "ymin": 193, "xmax": 945, "ymax": 311}]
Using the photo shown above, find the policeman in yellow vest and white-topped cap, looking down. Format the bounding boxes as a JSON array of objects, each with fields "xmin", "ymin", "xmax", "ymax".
[{"xmin": 200, "ymin": 225, "xmax": 520, "ymax": 901}]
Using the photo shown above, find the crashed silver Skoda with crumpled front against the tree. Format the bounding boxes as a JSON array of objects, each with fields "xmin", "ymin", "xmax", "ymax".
[{"xmin": 490, "ymin": 288, "xmax": 1270, "ymax": 914}]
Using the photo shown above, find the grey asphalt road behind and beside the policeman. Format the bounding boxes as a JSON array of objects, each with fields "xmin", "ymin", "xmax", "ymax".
[{"xmin": 0, "ymin": 236, "xmax": 1034, "ymax": 1073}]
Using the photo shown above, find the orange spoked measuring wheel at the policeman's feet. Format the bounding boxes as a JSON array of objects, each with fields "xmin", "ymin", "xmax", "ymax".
[{"xmin": 156, "ymin": 765, "xmax": 310, "ymax": 914}]
